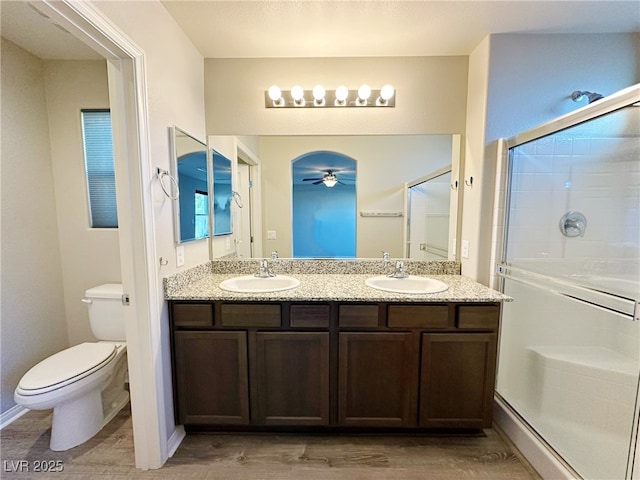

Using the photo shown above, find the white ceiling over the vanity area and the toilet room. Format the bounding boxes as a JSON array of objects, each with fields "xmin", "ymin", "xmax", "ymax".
[{"xmin": 0, "ymin": 0, "xmax": 640, "ymax": 59}]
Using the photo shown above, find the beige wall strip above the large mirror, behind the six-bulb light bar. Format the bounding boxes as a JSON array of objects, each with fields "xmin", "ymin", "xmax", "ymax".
[{"xmin": 205, "ymin": 56, "xmax": 467, "ymax": 135}]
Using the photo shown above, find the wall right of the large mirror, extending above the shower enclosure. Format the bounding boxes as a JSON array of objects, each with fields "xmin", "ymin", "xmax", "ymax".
[{"xmin": 462, "ymin": 34, "xmax": 640, "ymax": 284}]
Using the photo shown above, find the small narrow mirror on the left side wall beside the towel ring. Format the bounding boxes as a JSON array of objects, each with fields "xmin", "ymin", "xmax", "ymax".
[{"xmin": 170, "ymin": 126, "xmax": 210, "ymax": 243}]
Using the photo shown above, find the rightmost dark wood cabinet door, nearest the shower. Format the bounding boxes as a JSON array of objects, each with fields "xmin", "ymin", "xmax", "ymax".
[{"xmin": 419, "ymin": 333, "xmax": 496, "ymax": 428}]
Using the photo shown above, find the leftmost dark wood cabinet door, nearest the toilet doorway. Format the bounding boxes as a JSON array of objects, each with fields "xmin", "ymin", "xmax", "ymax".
[{"xmin": 174, "ymin": 331, "xmax": 249, "ymax": 425}]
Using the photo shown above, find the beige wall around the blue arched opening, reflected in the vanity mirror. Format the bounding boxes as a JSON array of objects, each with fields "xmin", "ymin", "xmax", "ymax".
[{"xmin": 258, "ymin": 135, "xmax": 451, "ymax": 258}]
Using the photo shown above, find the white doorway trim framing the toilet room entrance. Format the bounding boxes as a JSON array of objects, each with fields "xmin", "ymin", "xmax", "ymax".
[{"xmin": 29, "ymin": 0, "xmax": 171, "ymax": 470}]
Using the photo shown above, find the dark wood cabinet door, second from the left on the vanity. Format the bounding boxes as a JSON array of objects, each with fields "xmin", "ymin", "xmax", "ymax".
[{"xmin": 250, "ymin": 332, "xmax": 329, "ymax": 425}]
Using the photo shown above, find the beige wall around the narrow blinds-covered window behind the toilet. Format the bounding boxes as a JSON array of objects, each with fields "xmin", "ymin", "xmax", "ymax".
[{"xmin": 44, "ymin": 60, "xmax": 122, "ymax": 345}]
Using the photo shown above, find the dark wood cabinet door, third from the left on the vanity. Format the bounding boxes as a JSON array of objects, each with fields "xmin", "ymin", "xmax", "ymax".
[{"xmin": 338, "ymin": 332, "xmax": 418, "ymax": 427}]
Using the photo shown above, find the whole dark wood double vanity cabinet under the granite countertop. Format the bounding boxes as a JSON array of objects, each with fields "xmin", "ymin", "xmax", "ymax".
[{"xmin": 170, "ymin": 301, "xmax": 500, "ymax": 429}]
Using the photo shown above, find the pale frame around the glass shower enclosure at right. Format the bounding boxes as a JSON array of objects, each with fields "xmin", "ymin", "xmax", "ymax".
[{"xmin": 490, "ymin": 84, "xmax": 640, "ymax": 479}]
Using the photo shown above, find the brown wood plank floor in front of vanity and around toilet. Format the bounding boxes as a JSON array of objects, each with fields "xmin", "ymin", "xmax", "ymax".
[{"xmin": 0, "ymin": 408, "xmax": 540, "ymax": 480}]
